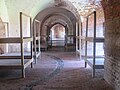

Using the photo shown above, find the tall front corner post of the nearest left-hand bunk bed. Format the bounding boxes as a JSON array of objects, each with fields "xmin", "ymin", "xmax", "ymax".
[{"xmin": 20, "ymin": 12, "xmax": 25, "ymax": 78}]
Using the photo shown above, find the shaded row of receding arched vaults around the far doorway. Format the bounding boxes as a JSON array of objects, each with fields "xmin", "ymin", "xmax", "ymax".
[{"xmin": 36, "ymin": 0, "xmax": 80, "ymax": 35}]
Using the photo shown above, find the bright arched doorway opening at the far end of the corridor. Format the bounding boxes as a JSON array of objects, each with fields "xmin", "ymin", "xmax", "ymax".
[{"xmin": 48, "ymin": 24, "xmax": 66, "ymax": 51}]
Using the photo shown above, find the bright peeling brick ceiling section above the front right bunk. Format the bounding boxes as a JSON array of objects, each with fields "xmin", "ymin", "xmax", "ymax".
[{"xmin": 69, "ymin": 0, "xmax": 102, "ymax": 16}]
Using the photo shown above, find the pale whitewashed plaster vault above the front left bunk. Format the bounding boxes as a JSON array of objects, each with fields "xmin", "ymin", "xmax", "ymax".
[{"xmin": 5, "ymin": 0, "xmax": 52, "ymax": 37}]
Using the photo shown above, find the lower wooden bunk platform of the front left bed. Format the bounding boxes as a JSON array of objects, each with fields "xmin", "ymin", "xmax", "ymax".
[{"xmin": 0, "ymin": 59, "xmax": 33, "ymax": 78}]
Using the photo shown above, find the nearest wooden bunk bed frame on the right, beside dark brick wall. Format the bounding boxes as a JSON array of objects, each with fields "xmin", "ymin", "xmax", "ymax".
[{"xmin": 80, "ymin": 11, "xmax": 104, "ymax": 77}]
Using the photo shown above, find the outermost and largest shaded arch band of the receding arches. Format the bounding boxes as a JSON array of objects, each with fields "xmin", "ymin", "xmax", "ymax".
[{"xmin": 35, "ymin": 6, "xmax": 80, "ymax": 21}]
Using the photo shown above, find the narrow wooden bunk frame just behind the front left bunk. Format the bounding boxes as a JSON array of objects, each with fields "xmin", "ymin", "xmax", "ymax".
[{"xmin": 33, "ymin": 19, "xmax": 41, "ymax": 64}]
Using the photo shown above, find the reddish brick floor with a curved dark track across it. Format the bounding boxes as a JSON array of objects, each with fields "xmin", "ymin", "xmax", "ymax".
[{"xmin": 0, "ymin": 51, "xmax": 113, "ymax": 90}]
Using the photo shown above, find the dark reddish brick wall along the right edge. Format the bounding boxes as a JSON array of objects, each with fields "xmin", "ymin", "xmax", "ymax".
[{"xmin": 102, "ymin": 0, "xmax": 120, "ymax": 90}]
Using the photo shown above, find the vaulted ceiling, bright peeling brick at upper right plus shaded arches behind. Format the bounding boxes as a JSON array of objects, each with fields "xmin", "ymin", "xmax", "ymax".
[{"xmin": 36, "ymin": 0, "xmax": 103, "ymax": 34}]
